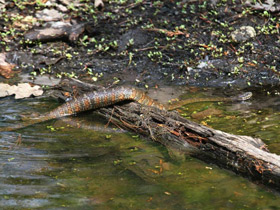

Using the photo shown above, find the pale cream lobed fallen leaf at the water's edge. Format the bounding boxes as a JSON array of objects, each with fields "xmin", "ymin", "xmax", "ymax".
[{"xmin": 0, "ymin": 83, "xmax": 43, "ymax": 99}]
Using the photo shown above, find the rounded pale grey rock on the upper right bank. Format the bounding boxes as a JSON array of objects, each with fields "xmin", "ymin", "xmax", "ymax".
[{"xmin": 231, "ymin": 26, "xmax": 257, "ymax": 43}]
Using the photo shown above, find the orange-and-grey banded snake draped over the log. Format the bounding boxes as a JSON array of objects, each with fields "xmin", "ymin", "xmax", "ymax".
[{"xmin": 0, "ymin": 87, "xmax": 252, "ymax": 131}]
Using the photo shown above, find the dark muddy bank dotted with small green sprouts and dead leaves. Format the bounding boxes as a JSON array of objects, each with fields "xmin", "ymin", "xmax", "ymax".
[{"xmin": 0, "ymin": 0, "xmax": 280, "ymax": 89}]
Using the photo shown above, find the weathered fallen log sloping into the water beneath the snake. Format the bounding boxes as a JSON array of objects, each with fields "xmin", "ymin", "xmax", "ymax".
[{"xmin": 56, "ymin": 79, "xmax": 280, "ymax": 191}]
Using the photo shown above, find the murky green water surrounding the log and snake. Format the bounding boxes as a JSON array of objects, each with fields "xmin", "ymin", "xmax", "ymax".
[{"xmin": 0, "ymin": 89, "xmax": 280, "ymax": 209}]
